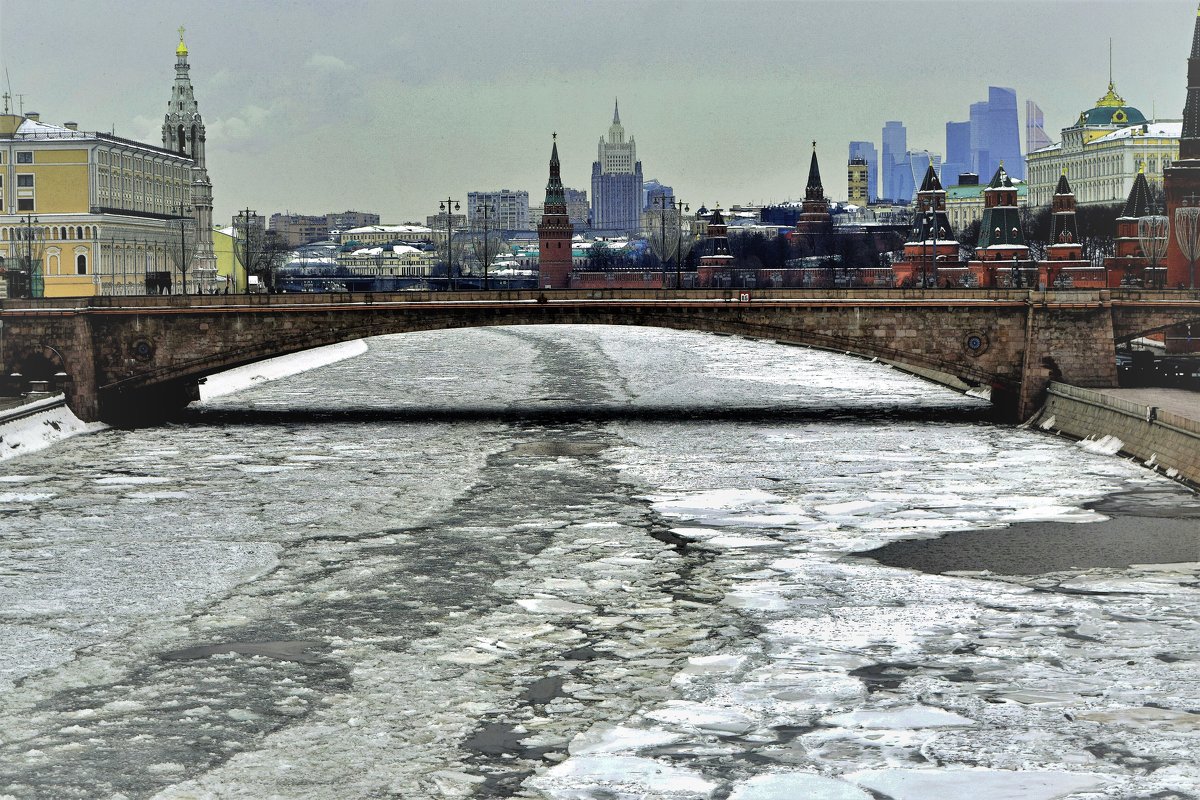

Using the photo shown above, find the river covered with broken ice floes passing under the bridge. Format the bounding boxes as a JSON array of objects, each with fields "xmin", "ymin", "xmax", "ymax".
[{"xmin": 0, "ymin": 327, "xmax": 1200, "ymax": 800}]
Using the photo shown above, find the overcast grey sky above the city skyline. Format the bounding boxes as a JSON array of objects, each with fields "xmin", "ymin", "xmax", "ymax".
[{"xmin": 0, "ymin": 0, "xmax": 1196, "ymax": 222}]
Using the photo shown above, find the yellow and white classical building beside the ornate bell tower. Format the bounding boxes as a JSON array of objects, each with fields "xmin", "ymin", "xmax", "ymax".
[{"xmin": 0, "ymin": 114, "xmax": 196, "ymax": 297}]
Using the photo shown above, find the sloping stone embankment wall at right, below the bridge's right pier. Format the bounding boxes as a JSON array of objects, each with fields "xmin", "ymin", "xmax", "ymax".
[{"xmin": 1030, "ymin": 383, "xmax": 1200, "ymax": 487}]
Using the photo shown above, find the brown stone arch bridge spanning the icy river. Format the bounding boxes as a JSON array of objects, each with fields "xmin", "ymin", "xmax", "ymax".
[{"xmin": 0, "ymin": 289, "xmax": 1200, "ymax": 423}]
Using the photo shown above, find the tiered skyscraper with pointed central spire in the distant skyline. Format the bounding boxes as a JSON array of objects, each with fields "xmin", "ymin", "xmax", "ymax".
[{"xmin": 592, "ymin": 101, "xmax": 642, "ymax": 234}]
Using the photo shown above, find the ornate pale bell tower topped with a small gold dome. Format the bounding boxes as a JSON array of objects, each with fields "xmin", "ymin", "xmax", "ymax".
[{"xmin": 162, "ymin": 28, "xmax": 217, "ymax": 290}]
